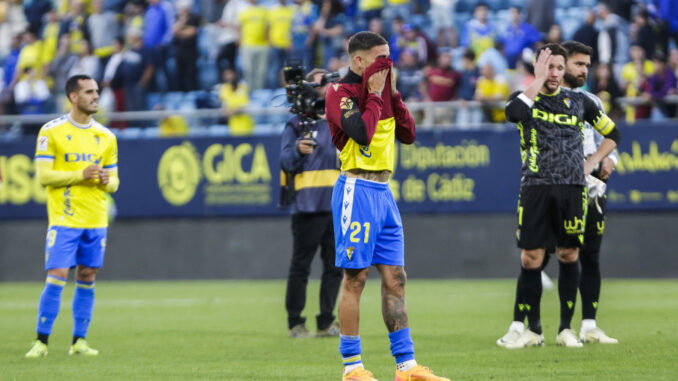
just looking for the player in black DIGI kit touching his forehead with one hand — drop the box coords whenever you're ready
[497,44,621,348]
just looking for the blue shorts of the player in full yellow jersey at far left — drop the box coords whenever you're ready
[45,226,108,270]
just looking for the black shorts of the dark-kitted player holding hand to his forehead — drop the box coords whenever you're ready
[516,185,587,250]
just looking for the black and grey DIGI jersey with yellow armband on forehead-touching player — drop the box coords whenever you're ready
[506,87,618,185]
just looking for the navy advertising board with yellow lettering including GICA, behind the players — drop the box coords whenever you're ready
[0,124,678,219]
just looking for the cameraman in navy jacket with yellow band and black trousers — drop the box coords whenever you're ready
[280,69,342,338]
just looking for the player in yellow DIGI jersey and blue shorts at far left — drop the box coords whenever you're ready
[26,75,120,358]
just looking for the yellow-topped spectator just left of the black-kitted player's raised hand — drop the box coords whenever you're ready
[474,64,509,123]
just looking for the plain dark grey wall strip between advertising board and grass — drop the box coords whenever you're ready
[0,212,678,281]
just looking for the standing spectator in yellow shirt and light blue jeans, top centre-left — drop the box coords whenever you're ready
[240,0,269,91]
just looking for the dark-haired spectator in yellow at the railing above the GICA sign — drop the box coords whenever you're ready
[219,68,254,136]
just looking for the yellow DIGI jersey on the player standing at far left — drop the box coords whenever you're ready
[35,115,118,229]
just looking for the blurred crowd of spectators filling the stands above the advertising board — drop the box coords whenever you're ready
[0,0,678,133]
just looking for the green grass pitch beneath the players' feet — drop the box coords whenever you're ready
[0,274,678,381]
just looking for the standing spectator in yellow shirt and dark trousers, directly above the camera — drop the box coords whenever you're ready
[267,0,294,88]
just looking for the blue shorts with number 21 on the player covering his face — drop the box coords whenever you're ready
[332,175,405,269]
